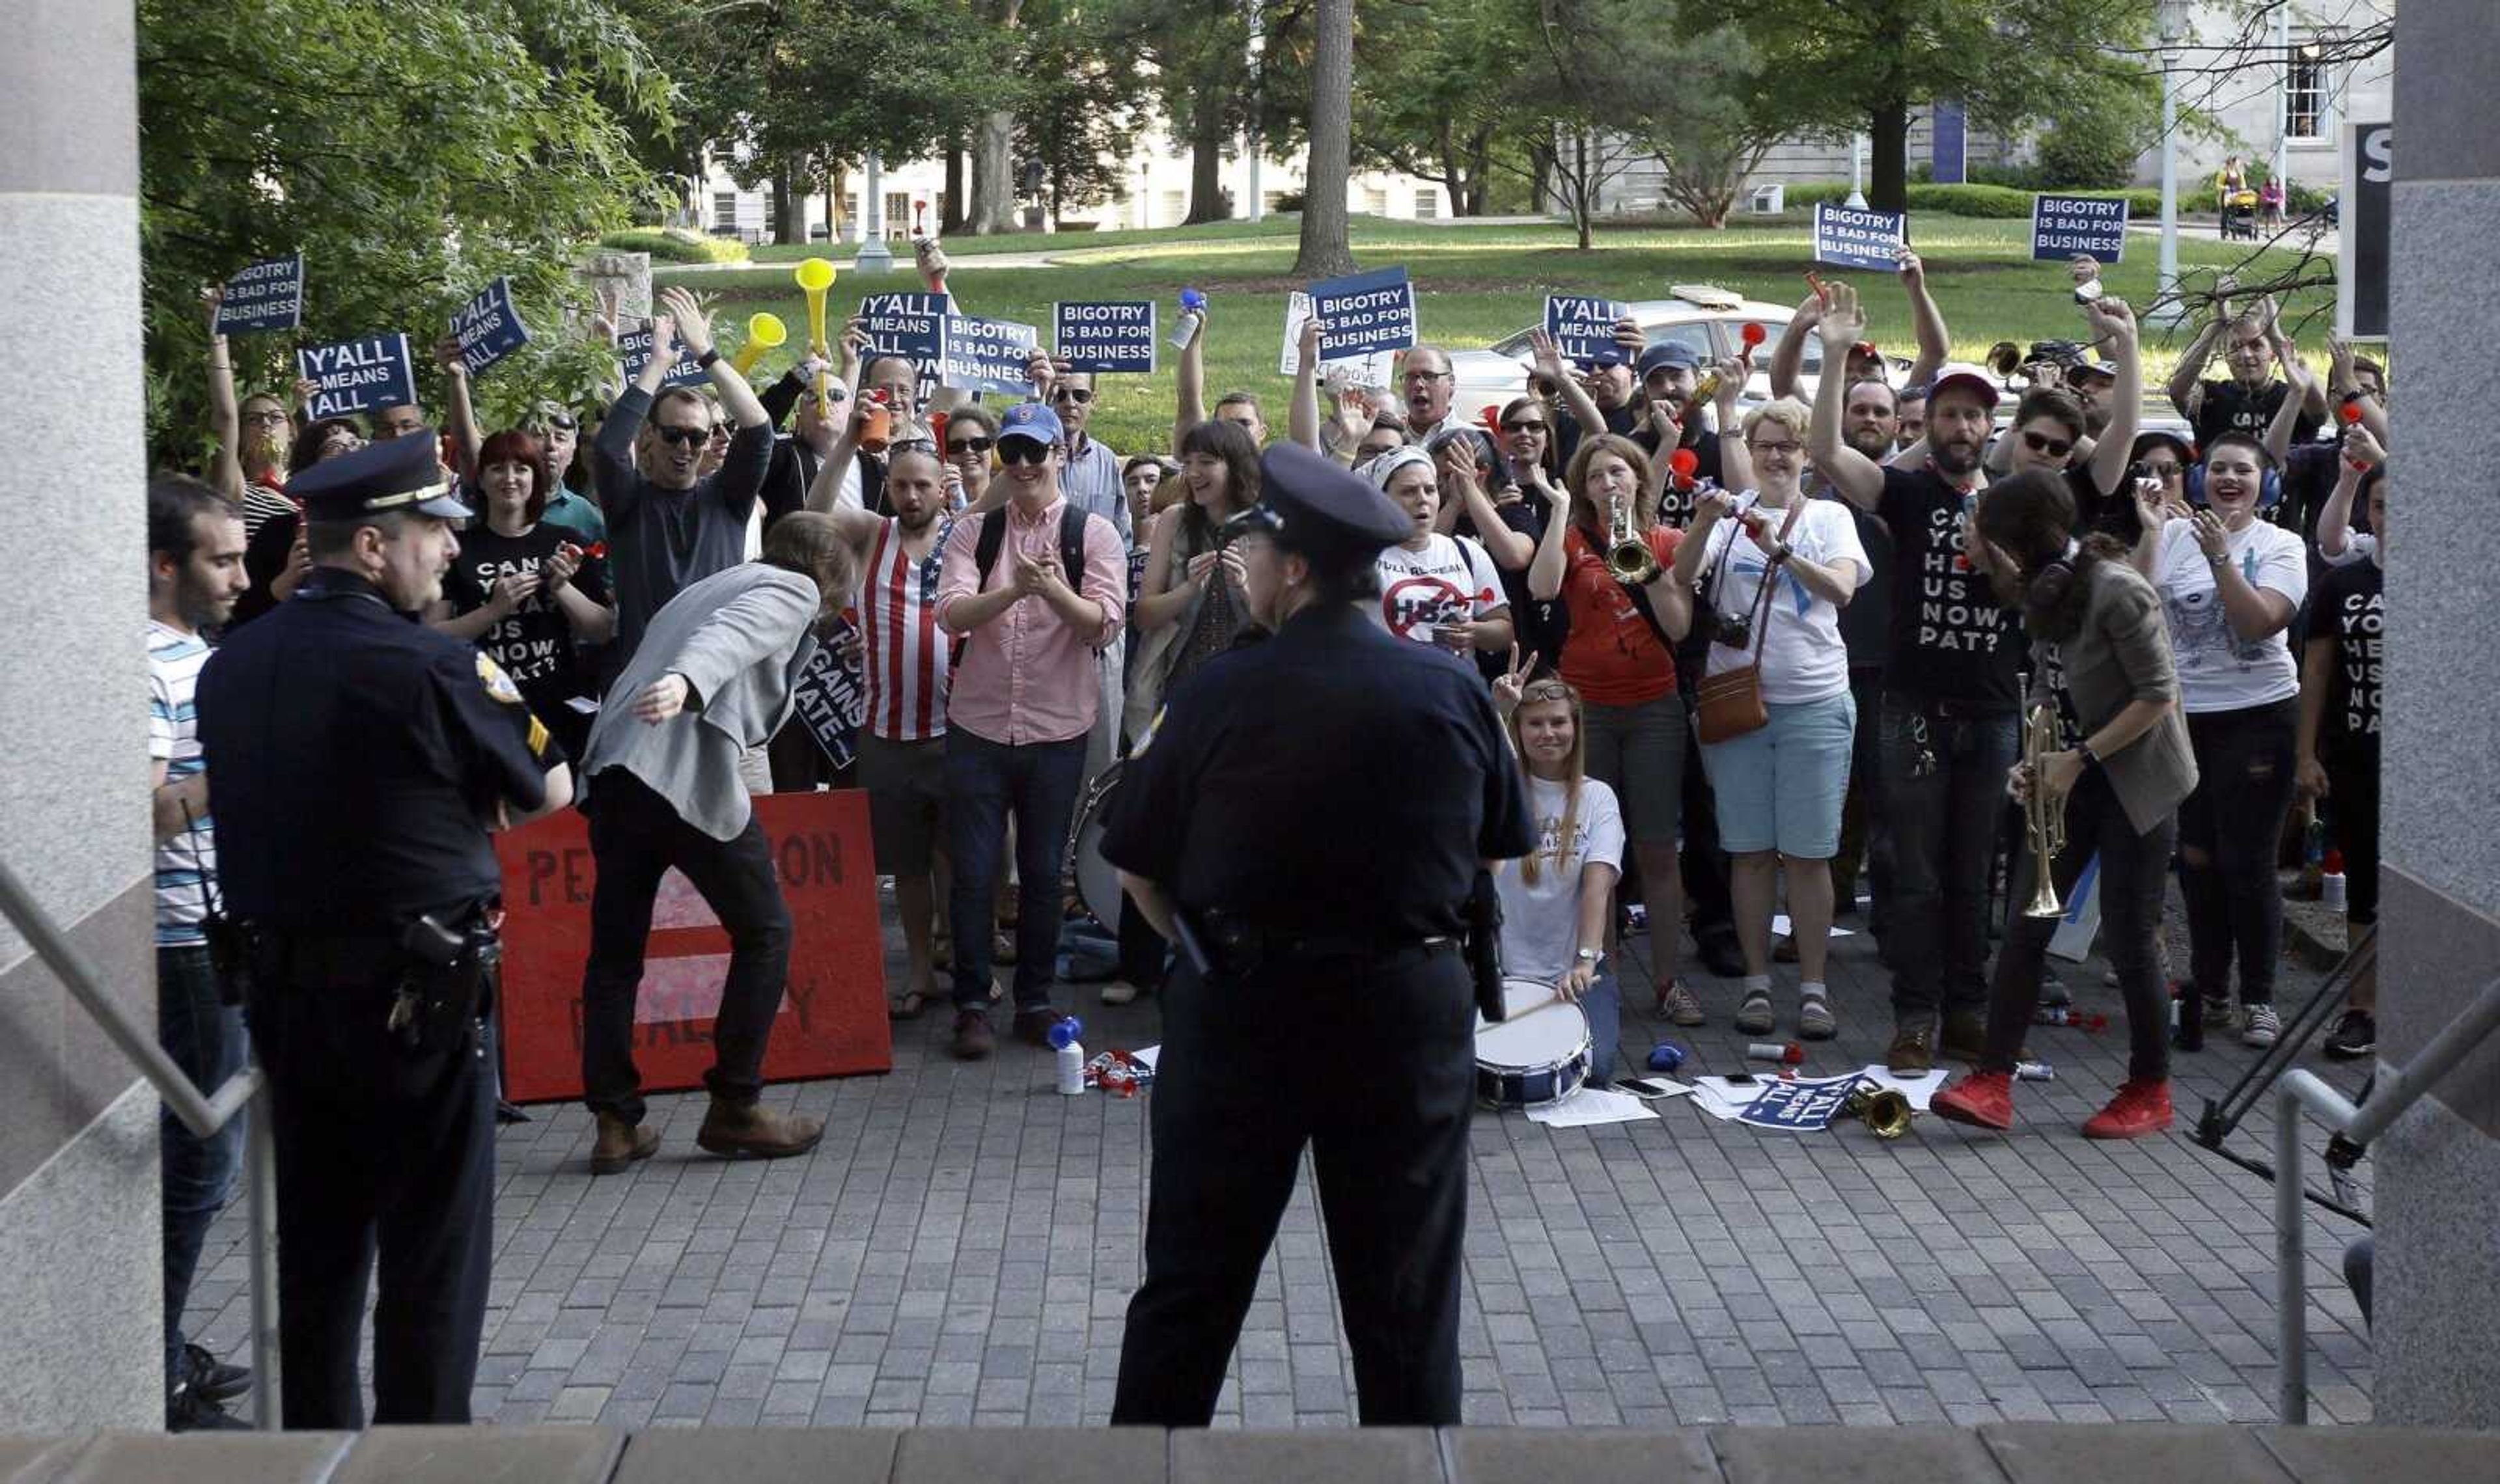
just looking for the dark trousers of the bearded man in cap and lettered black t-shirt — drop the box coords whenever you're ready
[1875,692,2020,1017]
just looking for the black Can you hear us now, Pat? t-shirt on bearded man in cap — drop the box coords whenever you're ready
[1875,465,2025,712]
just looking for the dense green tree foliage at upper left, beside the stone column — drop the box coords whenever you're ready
[137,0,670,465]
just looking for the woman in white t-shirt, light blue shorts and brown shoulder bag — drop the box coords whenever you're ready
[1675,397,1875,1039]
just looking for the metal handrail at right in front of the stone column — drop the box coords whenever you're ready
[2275,980,2500,1424]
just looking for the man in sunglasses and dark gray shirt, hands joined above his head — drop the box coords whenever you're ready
[590,287,773,665]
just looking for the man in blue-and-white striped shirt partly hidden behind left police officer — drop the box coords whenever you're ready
[148,474,250,1431]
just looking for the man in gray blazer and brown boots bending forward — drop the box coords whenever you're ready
[583,512,855,1174]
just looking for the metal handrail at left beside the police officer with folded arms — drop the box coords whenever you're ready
[0,862,277,1431]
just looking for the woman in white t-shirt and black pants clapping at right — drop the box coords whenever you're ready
[2135,432,2310,1047]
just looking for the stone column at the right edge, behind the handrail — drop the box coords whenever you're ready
[2372,0,2500,1427]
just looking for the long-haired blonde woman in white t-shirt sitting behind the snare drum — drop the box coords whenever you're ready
[1492,665,1622,1087]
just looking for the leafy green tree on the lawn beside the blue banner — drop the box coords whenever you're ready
[1710,0,2155,210]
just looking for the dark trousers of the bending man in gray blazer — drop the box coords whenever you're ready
[583,767,790,1124]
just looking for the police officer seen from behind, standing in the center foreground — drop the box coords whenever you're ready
[1102,445,1533,1427]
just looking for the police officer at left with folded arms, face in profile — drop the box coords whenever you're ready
[197,437,572,1429]
